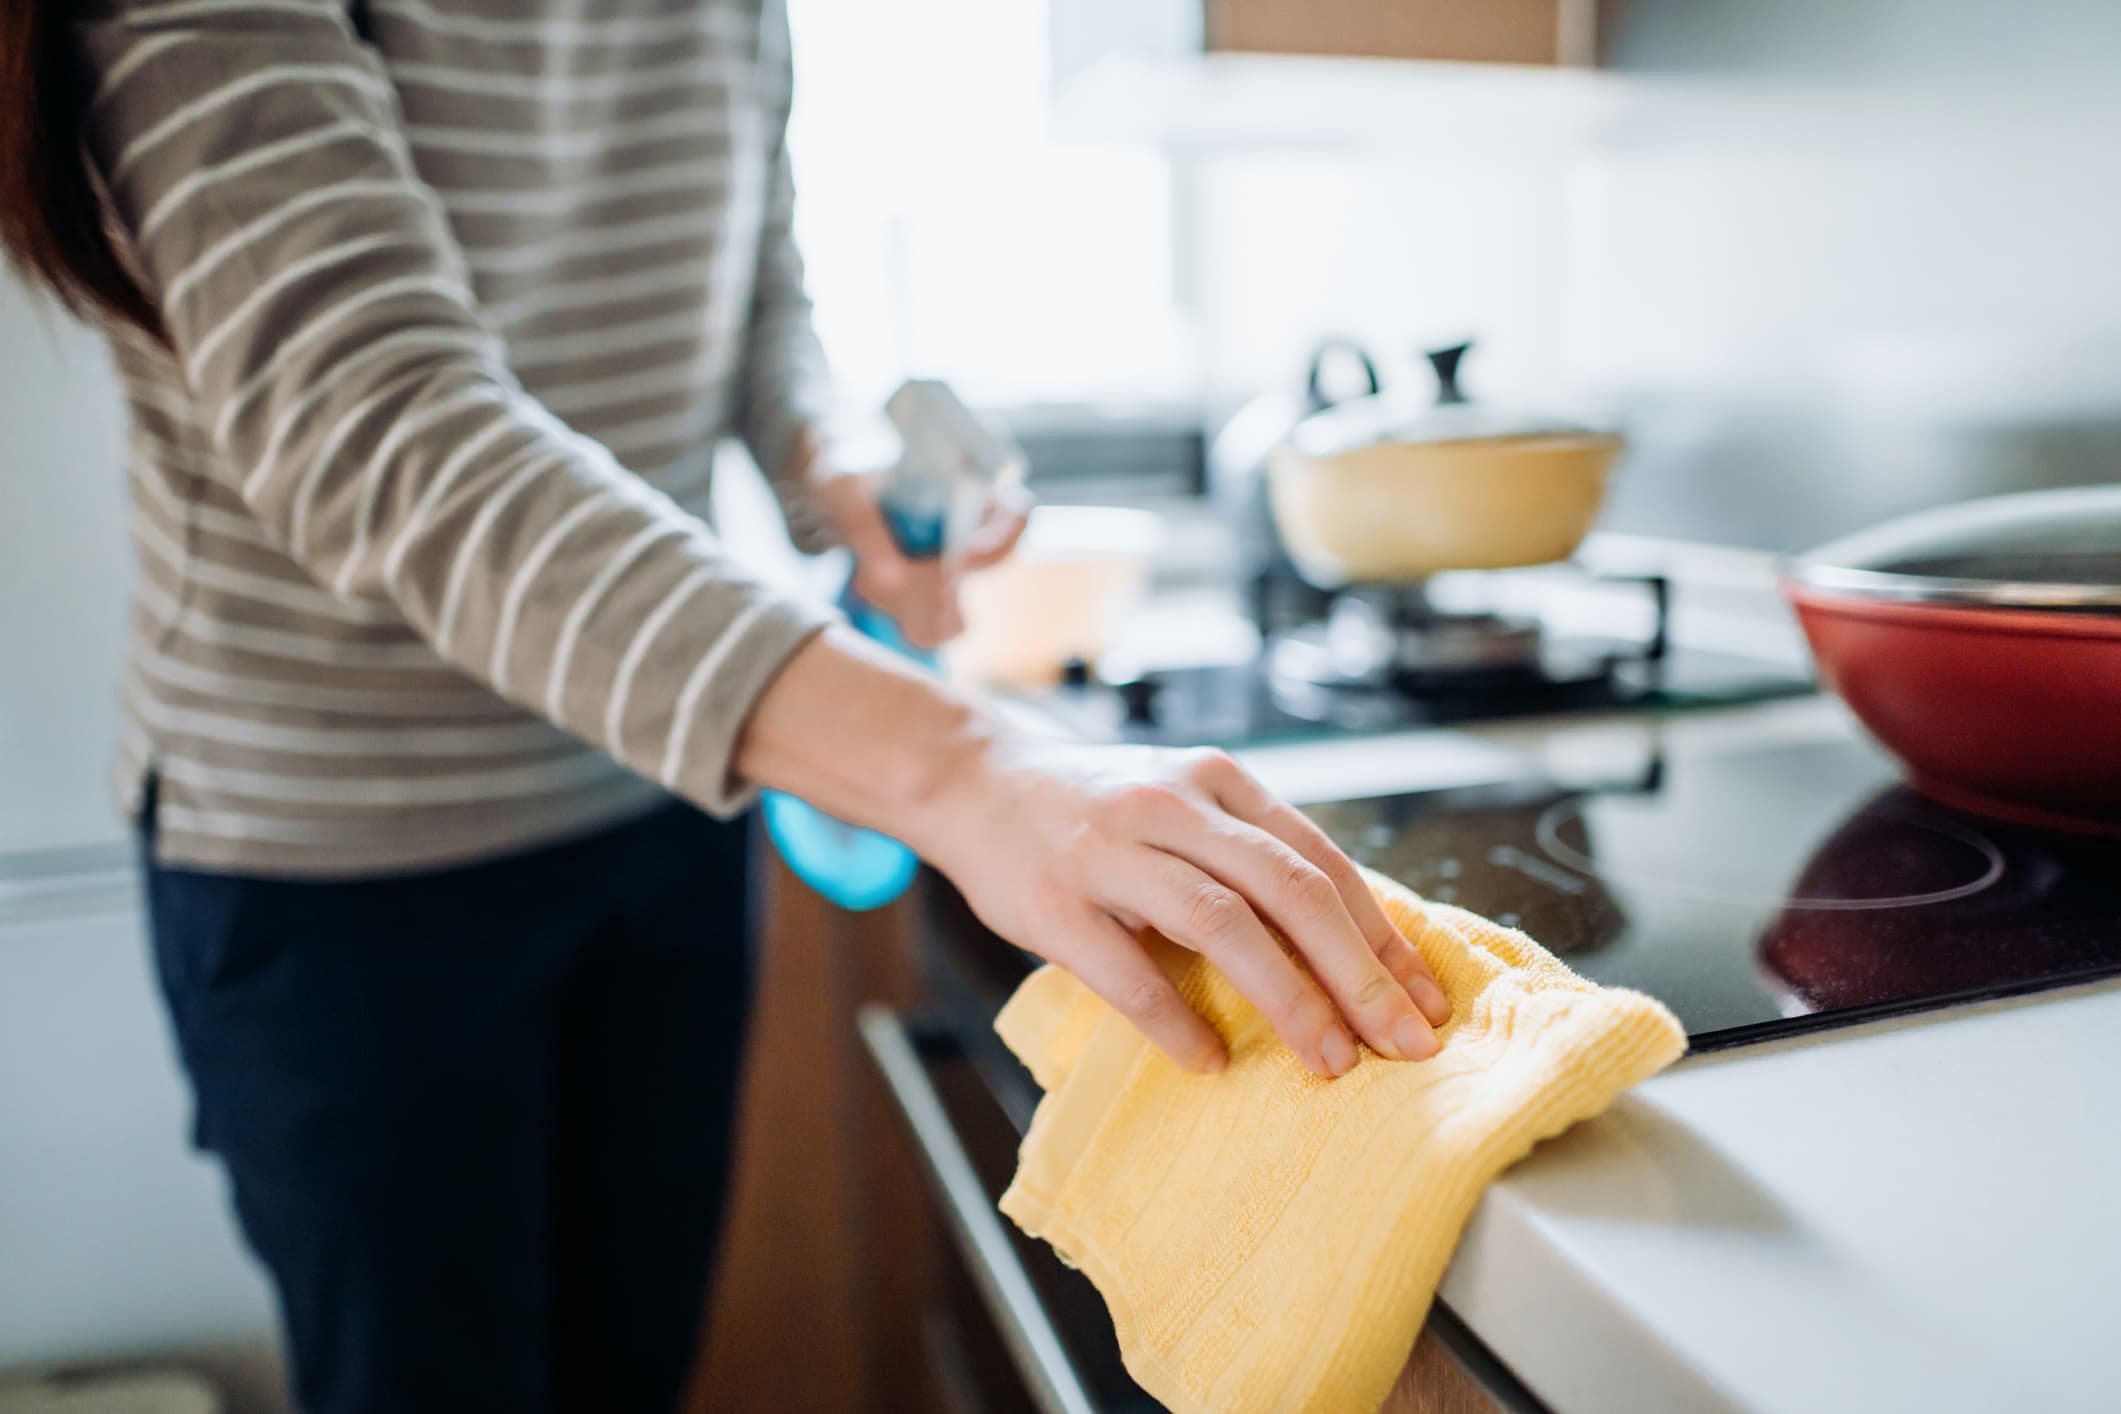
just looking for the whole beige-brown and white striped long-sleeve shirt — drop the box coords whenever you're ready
[81,0,844,876]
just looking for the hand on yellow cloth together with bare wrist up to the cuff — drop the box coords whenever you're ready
[736,628,1451,1075]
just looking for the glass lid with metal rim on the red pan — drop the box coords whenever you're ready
[1786,485,2121,613]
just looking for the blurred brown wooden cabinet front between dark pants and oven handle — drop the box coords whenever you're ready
[687,856,940,1414]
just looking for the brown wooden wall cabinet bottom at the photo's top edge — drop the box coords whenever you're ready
[1203,0,1610,66]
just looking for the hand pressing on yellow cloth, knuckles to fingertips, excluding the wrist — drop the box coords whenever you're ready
[918,733,1451,1075]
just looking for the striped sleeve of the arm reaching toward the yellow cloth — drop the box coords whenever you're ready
[81,0,829,810]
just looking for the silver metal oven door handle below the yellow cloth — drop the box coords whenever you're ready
[857,1003,1094,1414]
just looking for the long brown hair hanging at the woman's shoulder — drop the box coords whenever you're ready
[0,0,161,335]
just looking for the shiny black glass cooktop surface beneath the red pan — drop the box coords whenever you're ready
[1307,740,2121,1049]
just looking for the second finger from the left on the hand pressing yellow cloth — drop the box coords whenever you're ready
[1103,846,1360,1077]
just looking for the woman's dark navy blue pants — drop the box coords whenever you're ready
[148,806,755,1414]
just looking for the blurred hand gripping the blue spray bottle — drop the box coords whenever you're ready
[817,475,1031,649]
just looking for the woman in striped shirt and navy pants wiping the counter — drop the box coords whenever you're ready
[0,0,1444,1414]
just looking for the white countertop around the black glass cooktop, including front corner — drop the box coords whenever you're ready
[1243,700,2121,1414]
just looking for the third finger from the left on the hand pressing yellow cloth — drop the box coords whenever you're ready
[1145,803,1438,1060]
